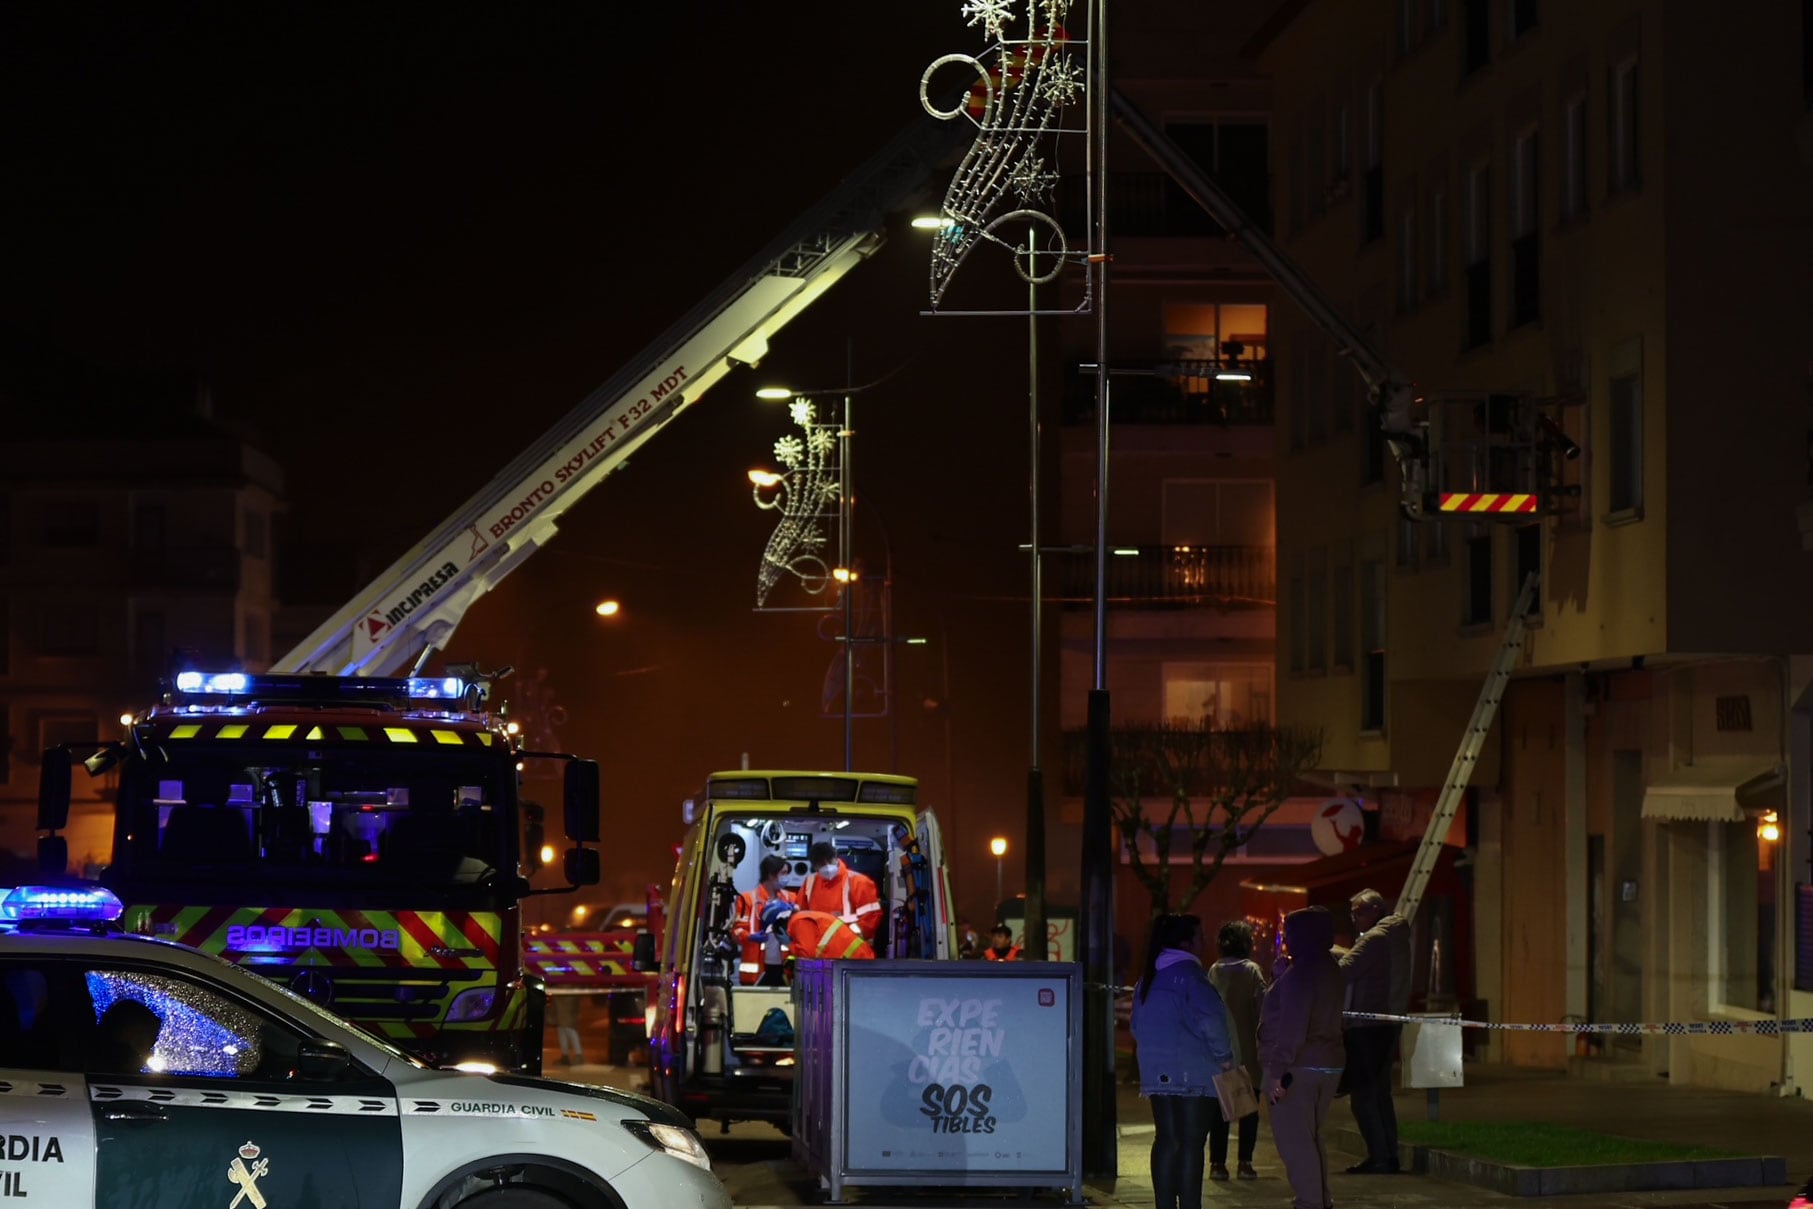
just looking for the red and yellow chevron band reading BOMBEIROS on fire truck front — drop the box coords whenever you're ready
[125,904,504,970]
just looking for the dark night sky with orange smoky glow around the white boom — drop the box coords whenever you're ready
[0,0,1075,917]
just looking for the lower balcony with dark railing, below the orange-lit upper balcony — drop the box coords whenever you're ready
[1048,546,1278,607]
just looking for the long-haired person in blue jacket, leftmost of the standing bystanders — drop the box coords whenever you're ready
[1133,915,1235,1209]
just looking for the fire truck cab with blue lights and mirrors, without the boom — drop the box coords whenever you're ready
[40,671,598,1073]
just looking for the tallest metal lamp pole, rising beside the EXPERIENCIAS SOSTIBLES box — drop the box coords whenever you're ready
[1081,0,1120,1178]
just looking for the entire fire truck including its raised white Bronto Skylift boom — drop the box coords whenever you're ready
[38,94,968,1071]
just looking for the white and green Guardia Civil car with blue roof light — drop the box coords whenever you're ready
[0,888,731,1209]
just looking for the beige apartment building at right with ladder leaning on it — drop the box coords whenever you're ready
[1253,0,1813,1091]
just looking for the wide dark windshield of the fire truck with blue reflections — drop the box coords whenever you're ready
[112,745,515,888]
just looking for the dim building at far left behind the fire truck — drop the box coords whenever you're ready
[0,416,283,868]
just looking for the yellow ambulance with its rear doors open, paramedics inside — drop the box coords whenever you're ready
[642,770,955,1129]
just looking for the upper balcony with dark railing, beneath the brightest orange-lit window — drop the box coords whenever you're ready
[1064,361,1273,428]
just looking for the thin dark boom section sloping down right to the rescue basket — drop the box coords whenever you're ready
[1110,91,1429,518]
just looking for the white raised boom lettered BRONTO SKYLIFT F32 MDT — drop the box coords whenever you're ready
[272,100,974,676]
